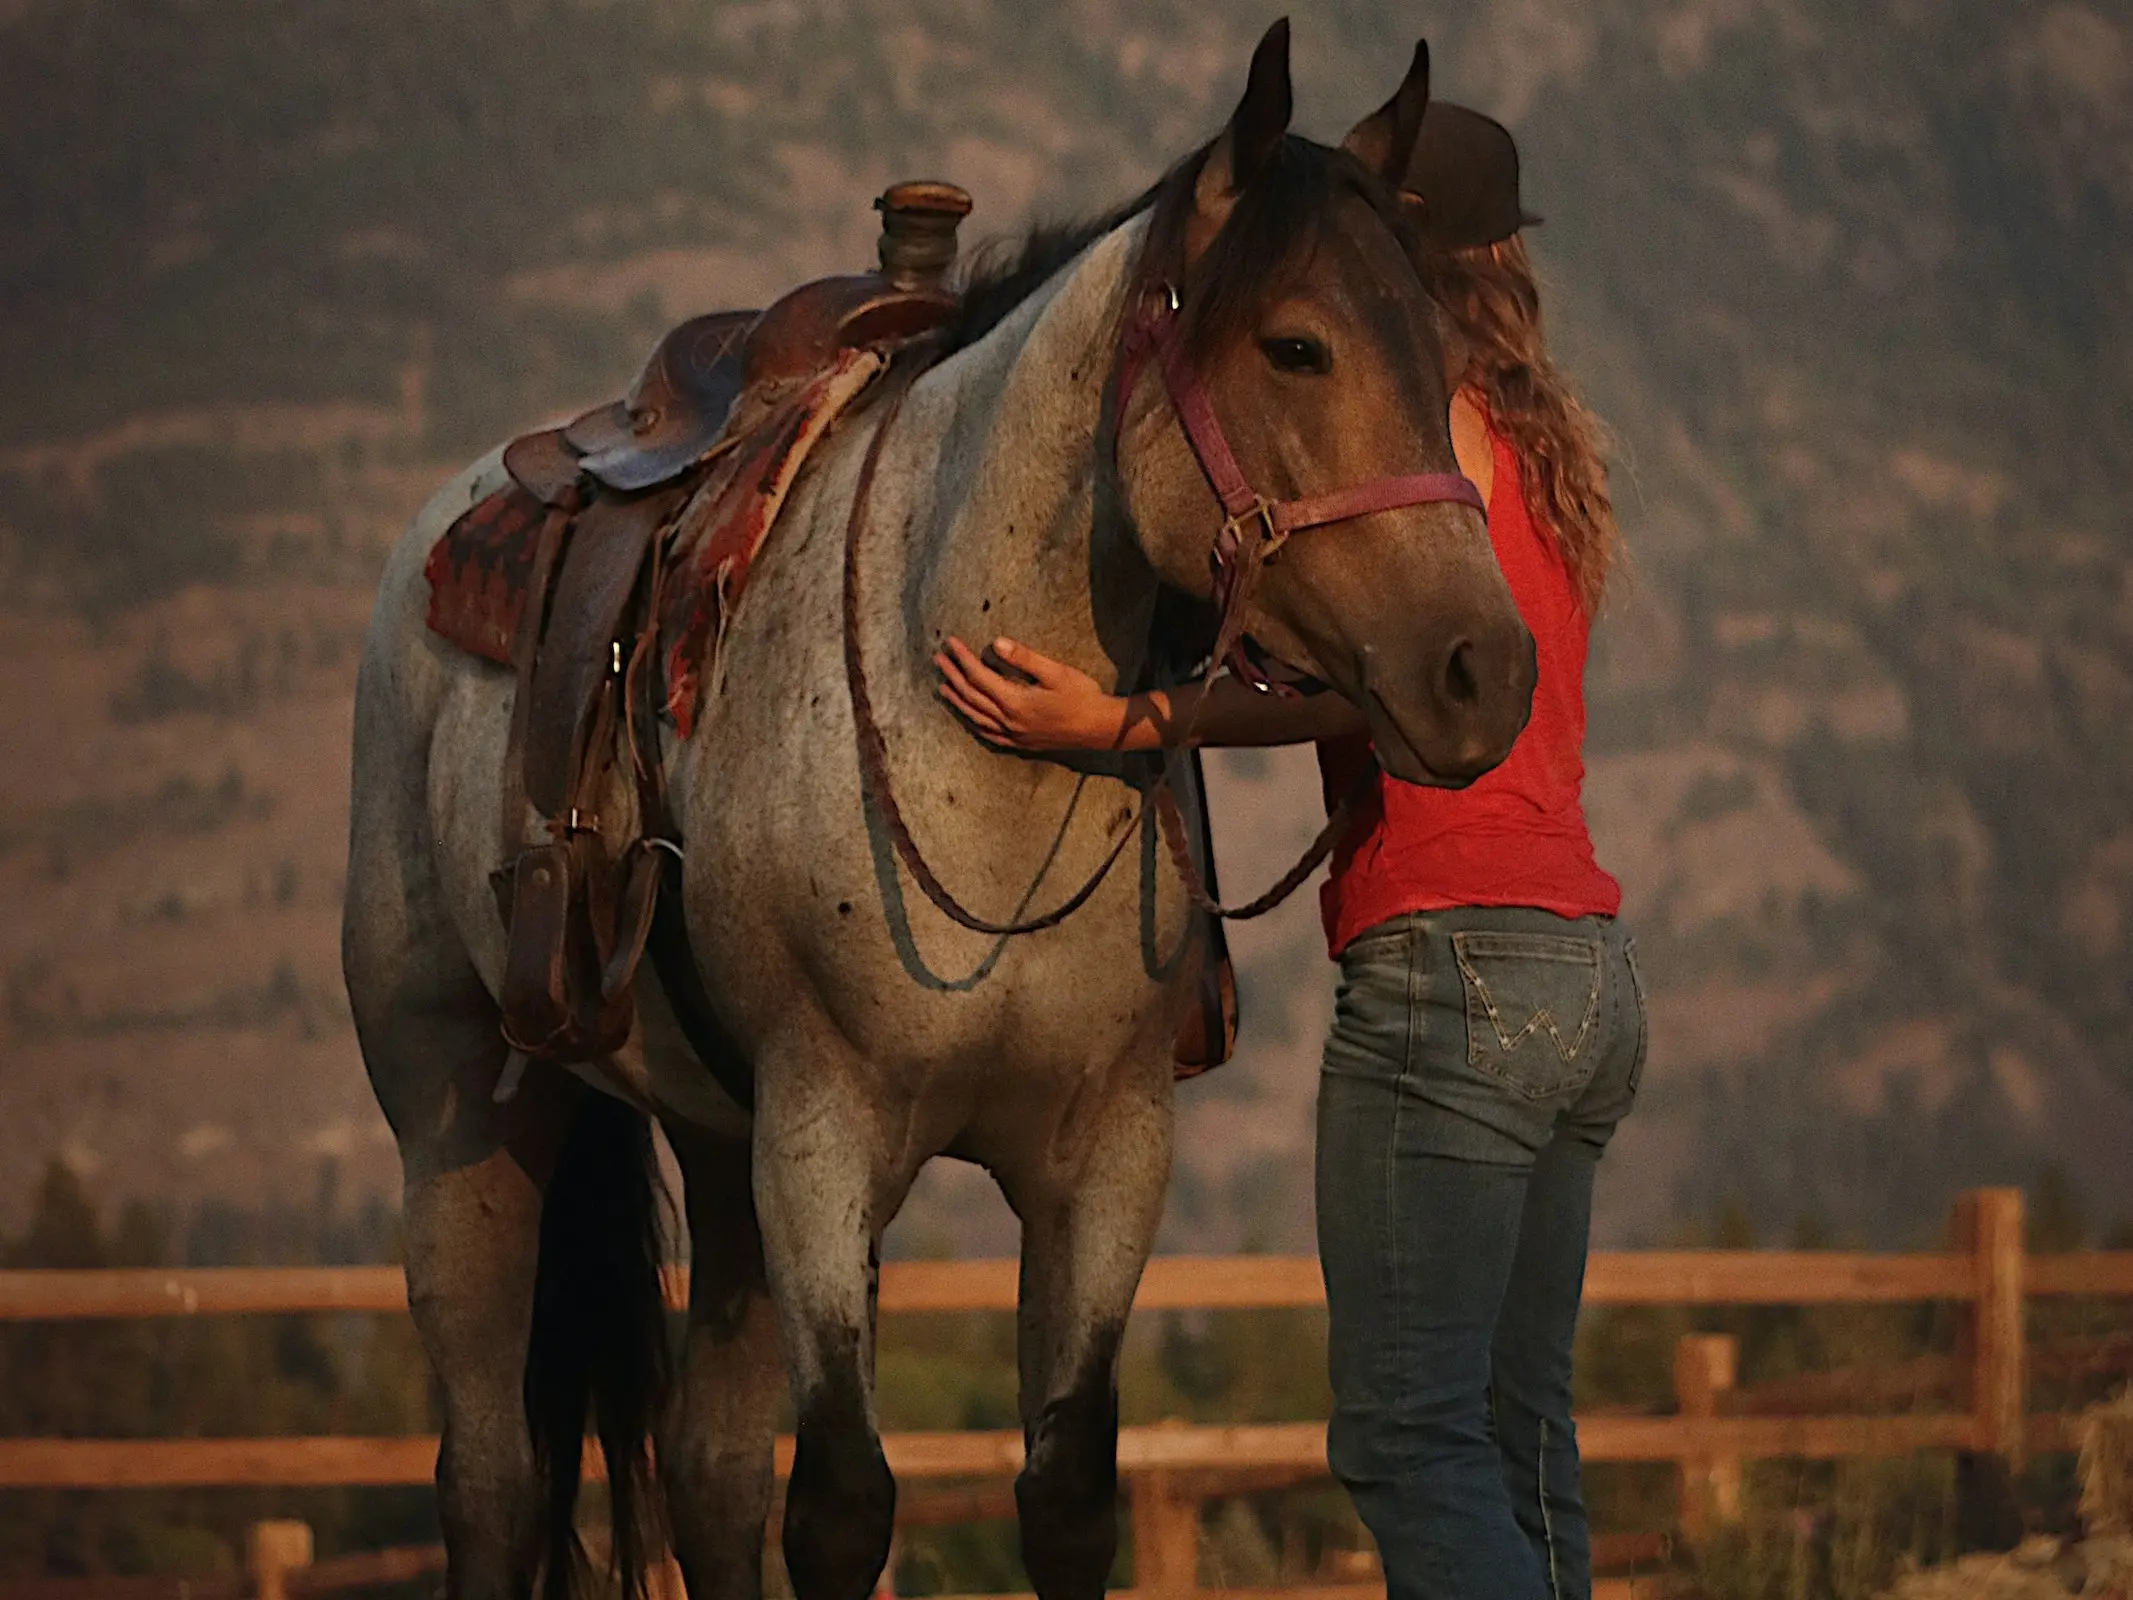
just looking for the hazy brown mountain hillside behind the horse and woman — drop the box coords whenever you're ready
[0,0,2133,1244]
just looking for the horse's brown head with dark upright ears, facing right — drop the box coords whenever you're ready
[1120,23,1534,785]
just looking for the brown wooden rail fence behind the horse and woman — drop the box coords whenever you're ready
[0,1188,2133,1594]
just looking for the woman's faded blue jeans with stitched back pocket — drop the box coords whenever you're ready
[1318,907,1645,1600]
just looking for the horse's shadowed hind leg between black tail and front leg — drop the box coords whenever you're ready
[659,1124,785,1600]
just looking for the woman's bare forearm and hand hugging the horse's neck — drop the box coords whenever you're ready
[934,638,1367,751]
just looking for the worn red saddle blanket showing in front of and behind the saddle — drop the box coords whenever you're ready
[424,350,885,738]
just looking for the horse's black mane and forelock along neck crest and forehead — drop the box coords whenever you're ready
[943,134,1423,354]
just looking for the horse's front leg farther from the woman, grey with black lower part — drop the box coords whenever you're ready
[755,1039,896,1600]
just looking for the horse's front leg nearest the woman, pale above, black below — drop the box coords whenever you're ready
[1003,1066,1171,1600]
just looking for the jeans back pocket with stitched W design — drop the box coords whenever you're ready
[1453,930,1604,1101]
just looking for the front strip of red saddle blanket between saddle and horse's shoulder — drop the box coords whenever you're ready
[659,350,887,738]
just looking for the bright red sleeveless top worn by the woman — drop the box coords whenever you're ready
[1318,433,1621,956]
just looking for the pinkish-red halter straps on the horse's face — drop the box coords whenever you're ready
[1116,286,1489,689]
